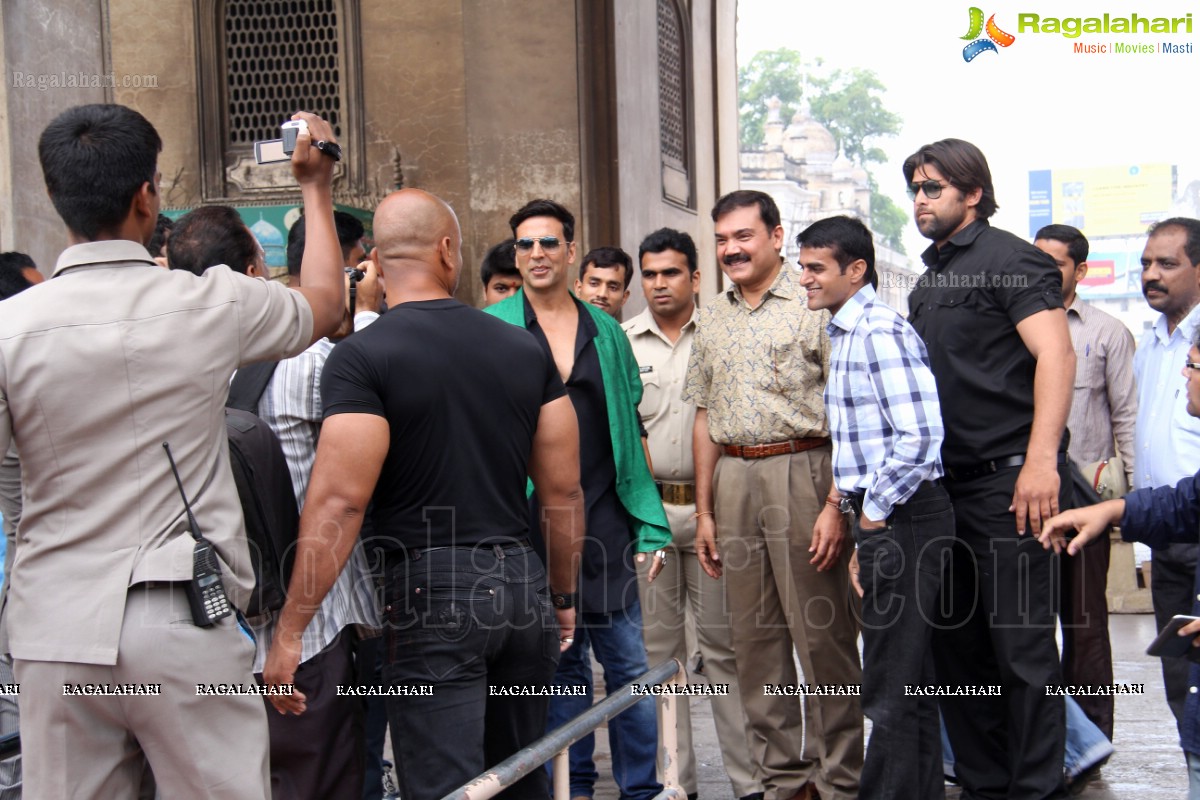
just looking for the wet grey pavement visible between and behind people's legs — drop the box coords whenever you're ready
[585,614,1187,800]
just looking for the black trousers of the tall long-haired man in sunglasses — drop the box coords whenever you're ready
[934,465,1070,800]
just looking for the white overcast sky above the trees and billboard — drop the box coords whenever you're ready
[738,0,1200,255]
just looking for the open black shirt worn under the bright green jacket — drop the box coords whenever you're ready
[524,297,637,612]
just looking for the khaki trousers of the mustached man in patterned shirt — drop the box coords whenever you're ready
[714,447,863,800]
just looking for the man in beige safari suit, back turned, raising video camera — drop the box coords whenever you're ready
[0,104,344,800]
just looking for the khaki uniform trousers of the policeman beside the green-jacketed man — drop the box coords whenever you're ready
[637,504,762,798]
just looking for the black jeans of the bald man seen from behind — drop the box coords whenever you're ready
[383,546,558,800]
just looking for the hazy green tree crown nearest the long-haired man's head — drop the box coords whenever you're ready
[809,67,900,166]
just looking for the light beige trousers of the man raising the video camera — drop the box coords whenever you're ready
[14,584,270,800]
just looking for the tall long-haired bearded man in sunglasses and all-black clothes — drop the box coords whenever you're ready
[904,139,1075,799]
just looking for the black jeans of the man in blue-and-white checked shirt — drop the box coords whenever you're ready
[853,482,954,800]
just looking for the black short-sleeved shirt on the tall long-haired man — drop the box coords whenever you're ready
[908,219,1066,468]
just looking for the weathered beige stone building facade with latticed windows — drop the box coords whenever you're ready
[0,0,738,313]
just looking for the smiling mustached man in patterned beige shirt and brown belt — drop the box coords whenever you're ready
[683,191,863,800]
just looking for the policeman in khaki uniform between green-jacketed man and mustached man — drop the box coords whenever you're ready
[622,228,761,799]
